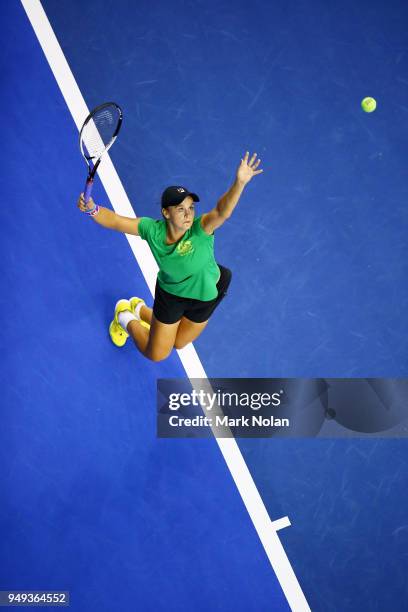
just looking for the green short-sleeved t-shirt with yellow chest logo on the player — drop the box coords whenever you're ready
[139,216,220,302]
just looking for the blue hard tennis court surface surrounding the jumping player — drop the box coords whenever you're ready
[0,0,408,612]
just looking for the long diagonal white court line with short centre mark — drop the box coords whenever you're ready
[21,0,310,612]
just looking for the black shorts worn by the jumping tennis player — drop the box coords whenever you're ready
[153,264,232,324]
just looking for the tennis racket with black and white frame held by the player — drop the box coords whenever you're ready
[79,102,123,203]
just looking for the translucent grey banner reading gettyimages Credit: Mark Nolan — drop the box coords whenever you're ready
[157,378,408,438]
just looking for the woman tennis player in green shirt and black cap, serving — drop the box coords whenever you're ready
[78,151,263,361]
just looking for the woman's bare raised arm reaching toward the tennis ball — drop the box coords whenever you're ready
[201,151,263,234]
